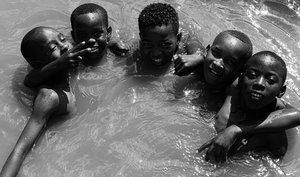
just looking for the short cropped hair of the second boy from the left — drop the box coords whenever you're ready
[71,3,108,28]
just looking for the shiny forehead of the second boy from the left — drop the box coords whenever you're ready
[74,12,105,28]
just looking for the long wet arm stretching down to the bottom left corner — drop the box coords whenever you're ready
[0,89,59,177]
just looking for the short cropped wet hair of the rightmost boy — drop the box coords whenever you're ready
[244,51,287,85]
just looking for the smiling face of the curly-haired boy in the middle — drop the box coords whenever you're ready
[140,24,180,66]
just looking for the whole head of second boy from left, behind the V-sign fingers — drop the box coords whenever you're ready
[71,3,111,60]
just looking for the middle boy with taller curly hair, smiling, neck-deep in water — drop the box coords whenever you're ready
[128,3,203,75]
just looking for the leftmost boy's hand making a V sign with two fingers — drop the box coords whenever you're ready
[58,41,93,68]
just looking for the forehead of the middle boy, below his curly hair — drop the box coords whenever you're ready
[140,24,176,40]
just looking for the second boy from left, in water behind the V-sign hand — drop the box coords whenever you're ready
[71,3,128,66]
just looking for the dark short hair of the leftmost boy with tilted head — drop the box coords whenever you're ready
[20,26,50,68]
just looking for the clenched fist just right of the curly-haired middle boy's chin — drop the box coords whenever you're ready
[174,54,204,76]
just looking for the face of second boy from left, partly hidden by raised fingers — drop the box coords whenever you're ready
[72,13,111,60]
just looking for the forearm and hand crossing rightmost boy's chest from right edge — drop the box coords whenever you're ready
[198,108,300,162]
